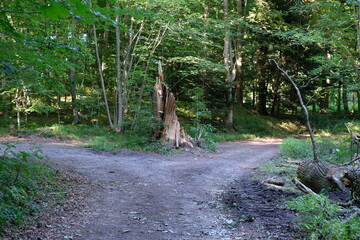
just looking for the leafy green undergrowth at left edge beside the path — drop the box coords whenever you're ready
[0,143,58,234]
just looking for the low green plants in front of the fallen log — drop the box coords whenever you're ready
[288,194,360,240]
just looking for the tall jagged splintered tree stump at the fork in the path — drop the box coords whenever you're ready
[153,62,193,148]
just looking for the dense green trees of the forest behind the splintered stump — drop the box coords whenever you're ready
[0,0,360,134]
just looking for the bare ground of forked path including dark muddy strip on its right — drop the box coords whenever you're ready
[0,139,302,240]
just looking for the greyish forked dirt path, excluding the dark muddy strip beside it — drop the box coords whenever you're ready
[7,139,281,240]
